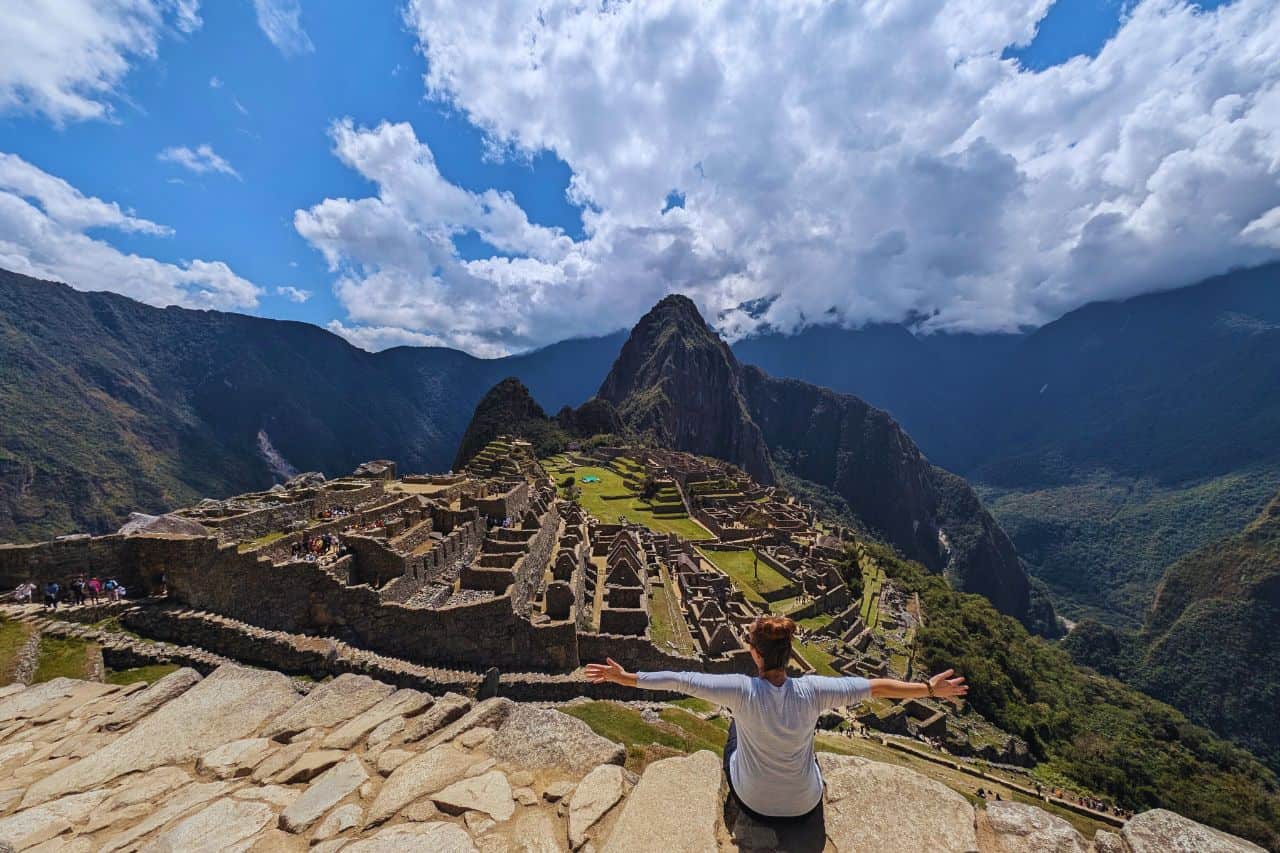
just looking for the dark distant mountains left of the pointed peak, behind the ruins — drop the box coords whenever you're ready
[0,270,623,542]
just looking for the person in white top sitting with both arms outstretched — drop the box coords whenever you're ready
[586,616,969,822]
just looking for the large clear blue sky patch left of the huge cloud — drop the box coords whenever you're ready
[0,0,582,325]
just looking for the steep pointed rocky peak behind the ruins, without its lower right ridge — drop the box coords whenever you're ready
[596,296,773,484]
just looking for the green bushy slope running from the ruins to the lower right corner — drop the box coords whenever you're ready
[865,544,1280,848]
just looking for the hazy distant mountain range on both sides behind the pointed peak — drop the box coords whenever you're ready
[0,264,1280,626]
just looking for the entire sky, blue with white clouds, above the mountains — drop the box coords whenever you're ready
[0,0,1280,355]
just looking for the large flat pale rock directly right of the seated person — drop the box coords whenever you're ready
[824,753,978,853]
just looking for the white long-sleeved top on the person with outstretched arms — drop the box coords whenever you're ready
[636,672,872,817]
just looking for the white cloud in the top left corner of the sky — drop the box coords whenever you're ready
[0,0,201,124]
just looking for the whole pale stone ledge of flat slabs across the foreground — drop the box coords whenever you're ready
[0,665,1262,853]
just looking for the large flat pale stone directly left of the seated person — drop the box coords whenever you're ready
[604,751,721,853]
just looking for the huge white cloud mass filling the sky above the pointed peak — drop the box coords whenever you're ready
[296,0,1280,351]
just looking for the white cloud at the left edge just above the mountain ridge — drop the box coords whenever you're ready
[0,152,261,309]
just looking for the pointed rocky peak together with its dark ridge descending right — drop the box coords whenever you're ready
[599,296,1056,633]
